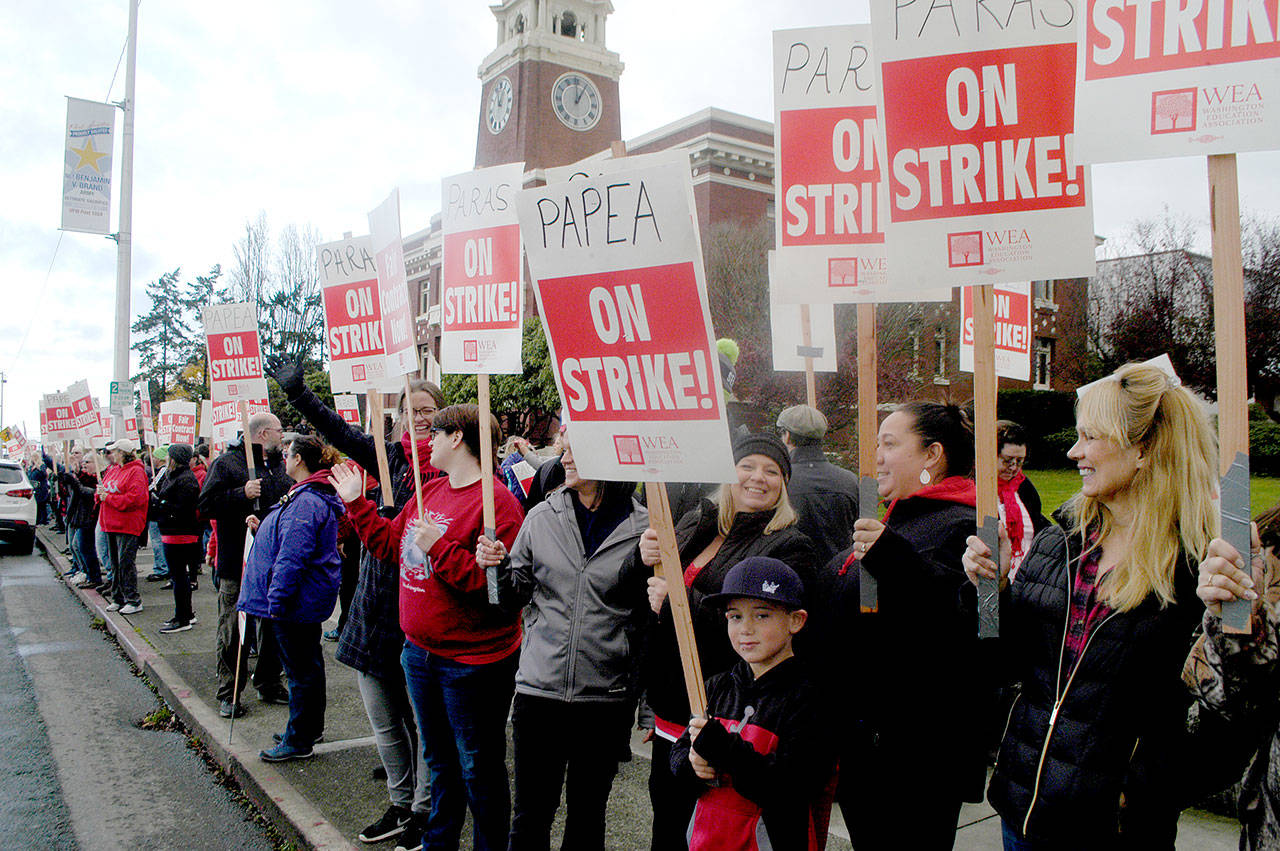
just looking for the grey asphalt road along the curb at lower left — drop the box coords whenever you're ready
[0,550,274,851]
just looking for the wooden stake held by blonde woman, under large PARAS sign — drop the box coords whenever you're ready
[973,284,1000,639]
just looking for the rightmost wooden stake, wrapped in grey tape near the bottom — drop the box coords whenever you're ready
[1208,154,1253,633]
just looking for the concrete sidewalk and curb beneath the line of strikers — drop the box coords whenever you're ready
[36,527,1239,851]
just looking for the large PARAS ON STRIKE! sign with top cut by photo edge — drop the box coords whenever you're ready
[870,0,1094,288]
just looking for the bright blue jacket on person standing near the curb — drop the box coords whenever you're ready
[237,471,346,623]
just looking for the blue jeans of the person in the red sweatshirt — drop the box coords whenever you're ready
[401,641,520,851]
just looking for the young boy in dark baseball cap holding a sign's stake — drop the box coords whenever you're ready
[671,555,833,851]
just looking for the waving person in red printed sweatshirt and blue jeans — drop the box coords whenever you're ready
[333,404,524,851]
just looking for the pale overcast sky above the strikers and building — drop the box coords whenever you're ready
[0,0,1280,431]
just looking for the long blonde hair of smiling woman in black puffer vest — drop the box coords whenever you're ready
[1066,363,1219,612]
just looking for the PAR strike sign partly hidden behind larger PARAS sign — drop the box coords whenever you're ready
[771,24,896,305]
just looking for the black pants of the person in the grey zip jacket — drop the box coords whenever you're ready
[508,694,635,851]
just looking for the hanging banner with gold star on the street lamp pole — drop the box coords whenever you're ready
[61,97,115,234]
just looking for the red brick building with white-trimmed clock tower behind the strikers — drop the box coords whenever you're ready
[404,0,1087,401]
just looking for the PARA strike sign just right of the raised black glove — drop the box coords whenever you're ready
[316,237,386,393]
